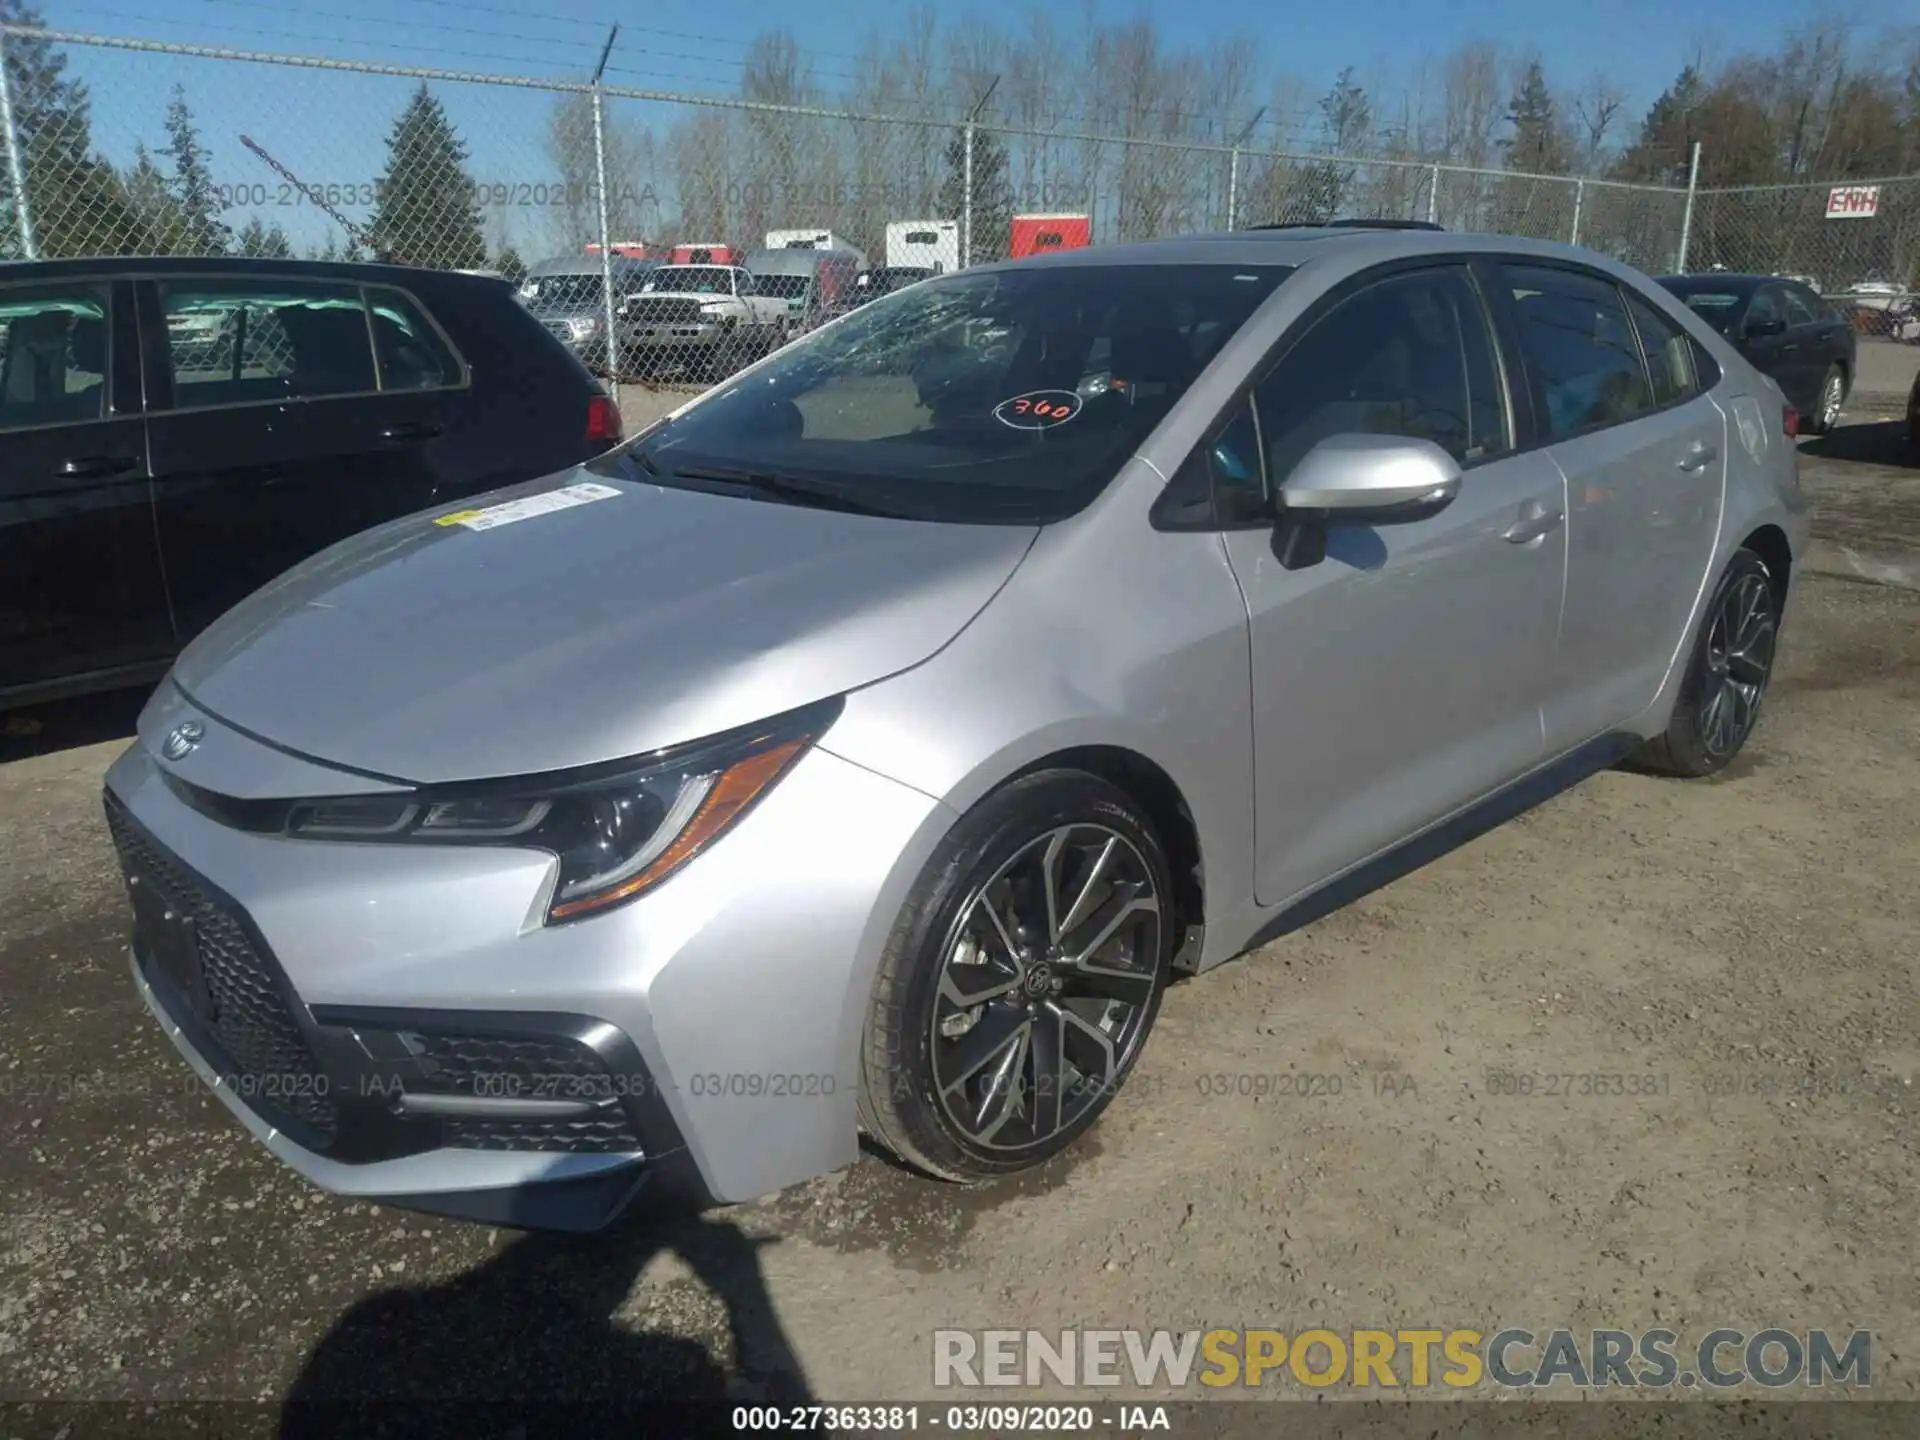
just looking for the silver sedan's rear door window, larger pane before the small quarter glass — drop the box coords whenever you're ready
[1501,265,1653,440]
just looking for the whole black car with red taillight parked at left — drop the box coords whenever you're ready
[0,259,620,708]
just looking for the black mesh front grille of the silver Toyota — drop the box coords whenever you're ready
[106,793,338,1140]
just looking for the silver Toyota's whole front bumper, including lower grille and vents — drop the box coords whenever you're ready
[106,710,945,1229]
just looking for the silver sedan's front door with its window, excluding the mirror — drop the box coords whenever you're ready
[1225,265,1565,904]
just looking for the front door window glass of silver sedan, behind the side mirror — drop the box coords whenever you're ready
[1254,265,1511,488]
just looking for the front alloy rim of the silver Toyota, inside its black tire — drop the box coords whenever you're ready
[931,824,1164,1152]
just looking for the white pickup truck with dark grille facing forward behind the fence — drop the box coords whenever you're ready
[618,265,787,380]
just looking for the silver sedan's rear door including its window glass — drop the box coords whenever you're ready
[1500,263,1726,753]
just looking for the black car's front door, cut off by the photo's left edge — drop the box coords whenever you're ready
[0,278,173,695]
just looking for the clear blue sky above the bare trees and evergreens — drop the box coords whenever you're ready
[15,0,1889,252]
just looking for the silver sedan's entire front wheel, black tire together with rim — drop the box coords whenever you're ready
[860,770,1175,1183]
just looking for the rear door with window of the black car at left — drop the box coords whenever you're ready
[142,276,445,641]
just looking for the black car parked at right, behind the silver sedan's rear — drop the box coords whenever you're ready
[1661,271,1859,436]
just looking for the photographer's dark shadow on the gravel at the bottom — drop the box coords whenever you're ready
[280,1217,812,1440]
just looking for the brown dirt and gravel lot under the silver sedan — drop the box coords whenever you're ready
[0,424,1920,1432]
